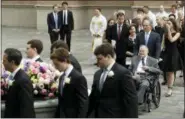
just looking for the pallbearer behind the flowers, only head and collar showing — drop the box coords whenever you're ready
[26,39,43,62]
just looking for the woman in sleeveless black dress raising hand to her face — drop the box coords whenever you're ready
[164,19,182,97]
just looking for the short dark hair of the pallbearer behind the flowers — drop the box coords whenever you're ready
[27,39,43,54]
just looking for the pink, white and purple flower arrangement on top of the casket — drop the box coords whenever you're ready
[1,60,60,100]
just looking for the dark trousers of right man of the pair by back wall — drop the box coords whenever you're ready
[60,25,71,51]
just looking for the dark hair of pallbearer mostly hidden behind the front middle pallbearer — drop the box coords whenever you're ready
[50,40,69,53]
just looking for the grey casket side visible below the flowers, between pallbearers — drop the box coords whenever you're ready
[1,98,58,118]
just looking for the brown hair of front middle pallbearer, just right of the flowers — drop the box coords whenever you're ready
[50,48,70,63]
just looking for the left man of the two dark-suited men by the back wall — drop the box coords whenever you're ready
[47,5,61,44]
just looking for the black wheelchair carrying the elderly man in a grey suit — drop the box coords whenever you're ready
[138,71,161,112]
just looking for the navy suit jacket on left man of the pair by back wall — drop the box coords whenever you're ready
[47,12,62,33]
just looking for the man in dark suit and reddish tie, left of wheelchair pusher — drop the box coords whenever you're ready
[109,12,129,66]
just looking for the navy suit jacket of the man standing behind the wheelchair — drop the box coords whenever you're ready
[135,31,161,59]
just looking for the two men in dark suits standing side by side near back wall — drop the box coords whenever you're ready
[47,2,74,51]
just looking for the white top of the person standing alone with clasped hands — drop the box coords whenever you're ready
[90,15,107,37]
